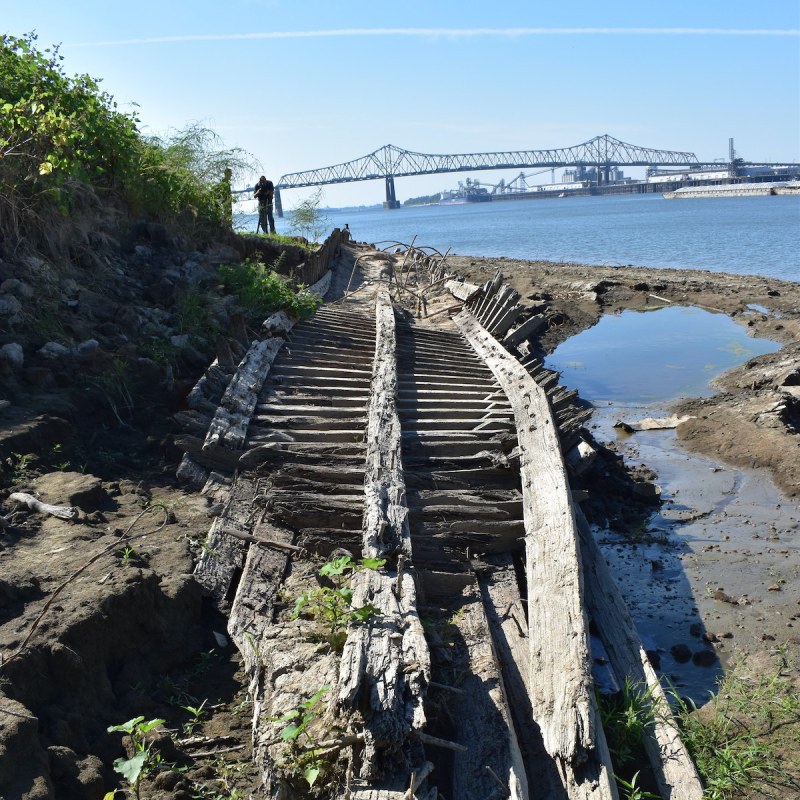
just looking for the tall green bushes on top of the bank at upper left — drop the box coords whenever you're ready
[0,34,255,252]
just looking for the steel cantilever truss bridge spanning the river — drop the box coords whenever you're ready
[275,134,704,216]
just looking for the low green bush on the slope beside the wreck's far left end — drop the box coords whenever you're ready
[219,254,322,319]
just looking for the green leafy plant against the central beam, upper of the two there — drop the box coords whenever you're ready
[292,556,386,652]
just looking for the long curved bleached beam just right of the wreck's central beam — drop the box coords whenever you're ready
[455,312,616,798]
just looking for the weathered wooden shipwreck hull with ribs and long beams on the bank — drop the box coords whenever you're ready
[181,234,702,800]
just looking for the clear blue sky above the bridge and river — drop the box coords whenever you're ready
[0,0,800,207]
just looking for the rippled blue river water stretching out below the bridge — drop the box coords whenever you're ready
[246,192,800,281]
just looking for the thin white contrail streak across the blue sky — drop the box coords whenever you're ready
[65,28,800,47]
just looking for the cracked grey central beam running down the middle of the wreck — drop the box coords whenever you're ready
[338,289,430,780]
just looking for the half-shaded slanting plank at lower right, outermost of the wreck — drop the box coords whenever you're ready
[576,512,703,800]
